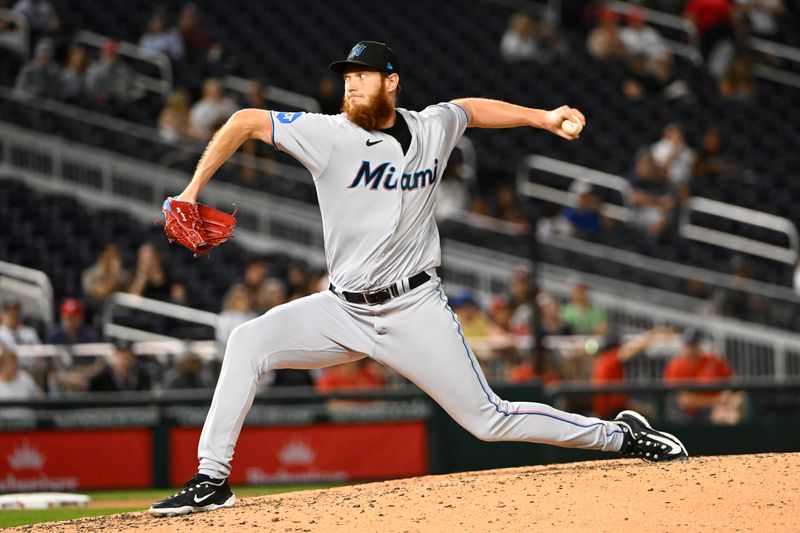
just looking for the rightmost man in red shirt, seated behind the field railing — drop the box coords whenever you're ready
[664,329,732,419]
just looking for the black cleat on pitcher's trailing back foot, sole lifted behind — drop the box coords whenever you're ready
[614,411,689,463]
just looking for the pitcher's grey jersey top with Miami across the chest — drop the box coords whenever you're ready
[270,103,468,291]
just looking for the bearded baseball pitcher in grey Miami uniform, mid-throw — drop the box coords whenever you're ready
[150,41,688,516]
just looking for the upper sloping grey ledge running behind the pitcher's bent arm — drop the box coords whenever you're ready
[0,85,308,186]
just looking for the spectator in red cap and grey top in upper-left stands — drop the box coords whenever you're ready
[86,39,134,106]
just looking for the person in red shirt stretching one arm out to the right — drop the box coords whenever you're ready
[592,327,675,419]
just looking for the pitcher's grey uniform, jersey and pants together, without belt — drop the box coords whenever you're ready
[191,104,623,478]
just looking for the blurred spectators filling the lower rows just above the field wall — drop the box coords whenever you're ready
[0,243,743,423]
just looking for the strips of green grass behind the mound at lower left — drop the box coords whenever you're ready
[0,484,339,528]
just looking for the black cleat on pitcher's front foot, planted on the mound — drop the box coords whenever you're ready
[148,474,236,516]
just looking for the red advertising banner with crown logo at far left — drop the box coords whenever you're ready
[0,428,153,492]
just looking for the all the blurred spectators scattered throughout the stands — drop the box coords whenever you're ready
[0,0,800,423]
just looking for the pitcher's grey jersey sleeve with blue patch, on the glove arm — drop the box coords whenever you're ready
[269,111,337,179]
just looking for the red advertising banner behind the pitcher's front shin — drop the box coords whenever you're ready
[170,421,428,485]
